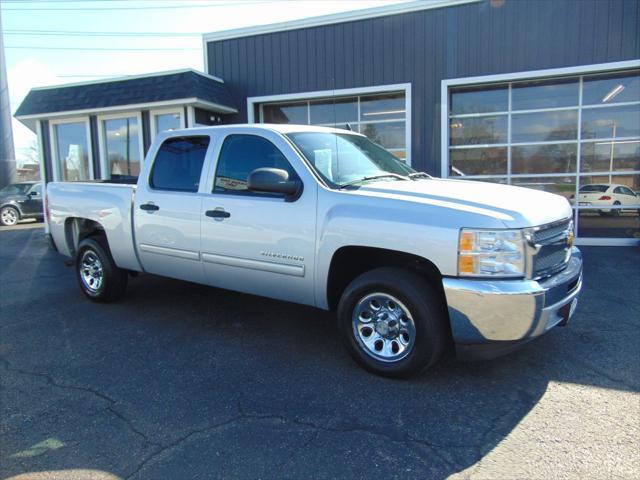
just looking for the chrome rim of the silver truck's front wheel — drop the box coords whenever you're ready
[351,293,416,362]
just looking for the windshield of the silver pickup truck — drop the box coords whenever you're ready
[287,132,415,187]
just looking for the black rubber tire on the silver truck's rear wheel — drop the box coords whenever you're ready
[75,236,128,303]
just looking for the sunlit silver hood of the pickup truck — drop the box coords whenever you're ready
[358,178,572,228]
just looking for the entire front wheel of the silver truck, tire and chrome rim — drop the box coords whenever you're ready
[338,267,448,377]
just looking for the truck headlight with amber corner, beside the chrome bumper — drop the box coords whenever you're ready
[458,228,525,277]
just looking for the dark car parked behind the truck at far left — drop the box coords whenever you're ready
[0,182,44,226]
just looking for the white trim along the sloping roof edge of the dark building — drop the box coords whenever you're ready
[202,0,483,44]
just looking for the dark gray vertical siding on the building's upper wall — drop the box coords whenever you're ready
[207,0,640,174]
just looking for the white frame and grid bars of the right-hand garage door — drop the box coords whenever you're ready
[440,60,640,245]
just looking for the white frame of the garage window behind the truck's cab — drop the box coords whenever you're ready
[247,83,411,165]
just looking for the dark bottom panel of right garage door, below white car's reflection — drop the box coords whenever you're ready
[578,209,640,239]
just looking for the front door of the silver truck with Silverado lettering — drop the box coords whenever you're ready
[201,130,317,304]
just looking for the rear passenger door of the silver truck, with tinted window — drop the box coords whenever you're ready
[134,135,211,283]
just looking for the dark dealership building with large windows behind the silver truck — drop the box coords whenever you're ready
[15,0,640,245]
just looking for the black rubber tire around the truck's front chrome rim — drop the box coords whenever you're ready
[338,267,450,377]
